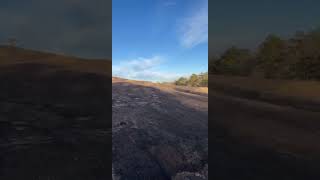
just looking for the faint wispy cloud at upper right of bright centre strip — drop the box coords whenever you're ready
[179,1,208,48]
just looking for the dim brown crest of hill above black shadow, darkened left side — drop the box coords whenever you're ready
[0,46,112,76]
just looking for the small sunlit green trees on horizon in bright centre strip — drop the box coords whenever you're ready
[174,72,208,87]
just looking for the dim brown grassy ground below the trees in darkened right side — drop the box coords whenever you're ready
[209,75,320,158]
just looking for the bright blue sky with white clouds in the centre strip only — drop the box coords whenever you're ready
[112,0,208,81]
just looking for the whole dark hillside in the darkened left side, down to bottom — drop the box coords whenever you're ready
[0,47,112,180]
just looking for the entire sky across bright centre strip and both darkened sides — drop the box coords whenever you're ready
[0,0,320,81]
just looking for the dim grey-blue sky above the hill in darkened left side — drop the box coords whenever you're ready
[0,0,112,59]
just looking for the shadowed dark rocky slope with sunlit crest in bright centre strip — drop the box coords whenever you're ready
[112,78,208,180]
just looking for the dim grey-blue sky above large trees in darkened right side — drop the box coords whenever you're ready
[209,0,320,56]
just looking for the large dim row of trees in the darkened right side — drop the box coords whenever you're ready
[209,29,320,80]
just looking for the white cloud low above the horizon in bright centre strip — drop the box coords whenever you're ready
[112,56,182,82]
